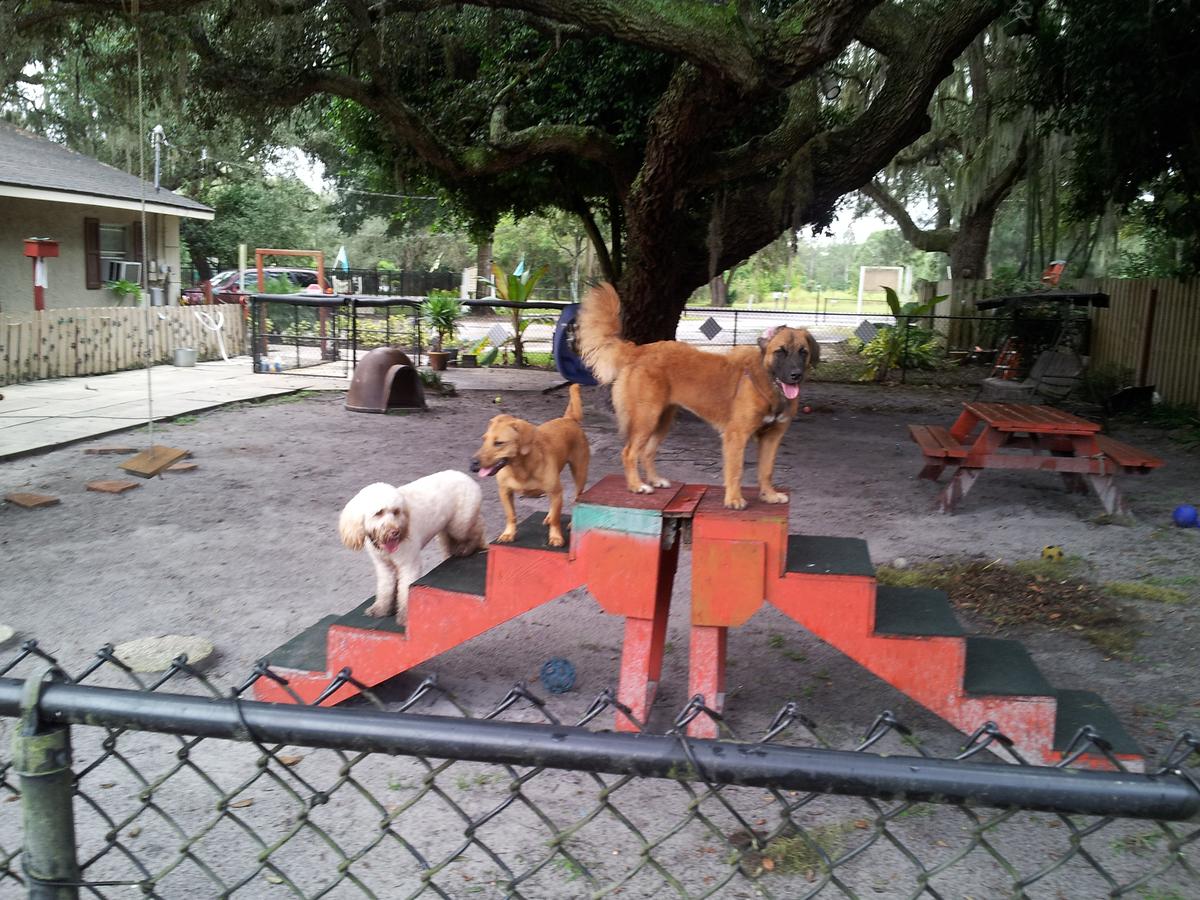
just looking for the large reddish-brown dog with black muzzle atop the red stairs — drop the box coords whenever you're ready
[578,284,820,509]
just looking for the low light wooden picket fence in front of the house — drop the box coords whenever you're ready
[0,305,246,384]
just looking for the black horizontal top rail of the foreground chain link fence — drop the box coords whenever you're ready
[0,678,1200,821]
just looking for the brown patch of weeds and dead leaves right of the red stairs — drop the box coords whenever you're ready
[876,557,1132,658]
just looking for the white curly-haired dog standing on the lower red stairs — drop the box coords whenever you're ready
[337,470,485,625]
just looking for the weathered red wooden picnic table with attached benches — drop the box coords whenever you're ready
[908,402,1163,514]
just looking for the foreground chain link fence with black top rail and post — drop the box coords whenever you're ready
[0,641,1200,900]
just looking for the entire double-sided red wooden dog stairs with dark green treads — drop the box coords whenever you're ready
[256,476,1141,768]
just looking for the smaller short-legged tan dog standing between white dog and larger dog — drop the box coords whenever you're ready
[470,384,592,547]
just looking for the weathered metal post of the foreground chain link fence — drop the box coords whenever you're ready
[12,665,79,900]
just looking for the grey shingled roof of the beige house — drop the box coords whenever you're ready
[0,121,212,212]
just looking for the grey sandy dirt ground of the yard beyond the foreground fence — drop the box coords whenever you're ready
[0,383,1200,896]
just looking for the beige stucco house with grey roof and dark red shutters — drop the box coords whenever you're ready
[0,121,212,314]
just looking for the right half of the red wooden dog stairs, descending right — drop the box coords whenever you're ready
[690,488,1142,768]
